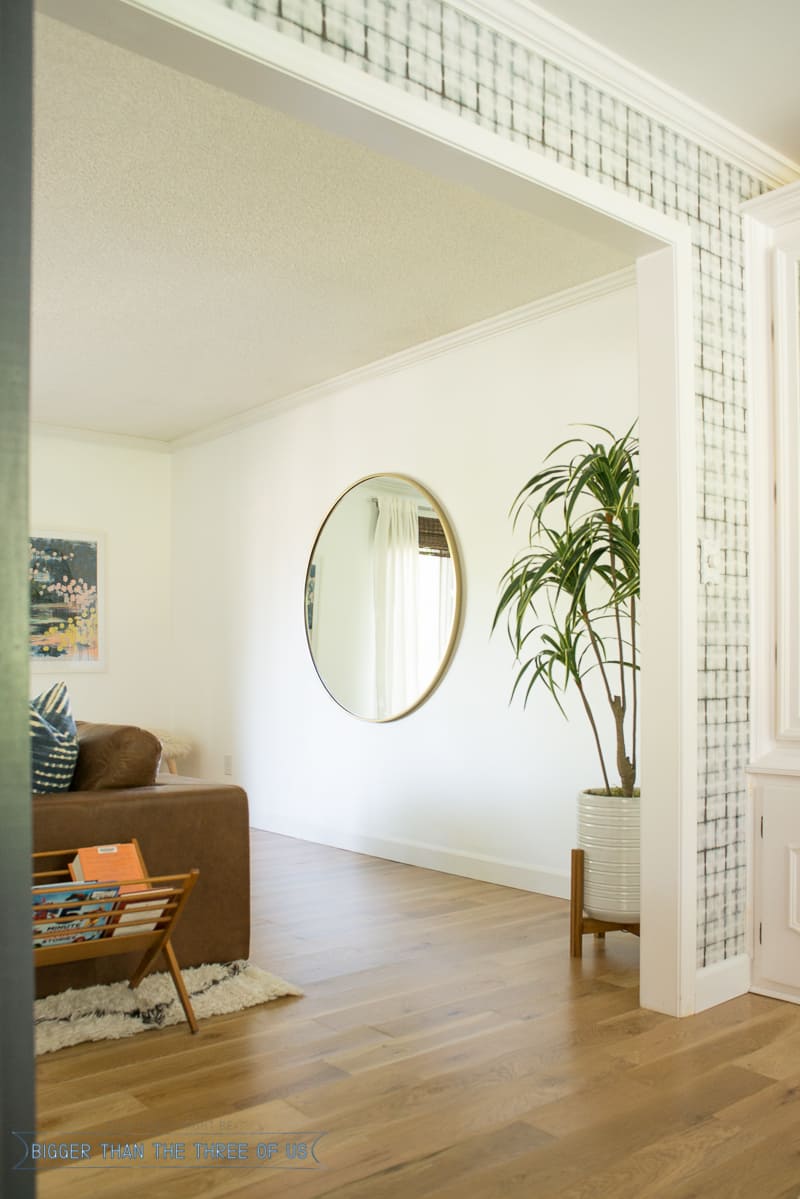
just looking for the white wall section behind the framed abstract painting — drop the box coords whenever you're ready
[30,430,173,728]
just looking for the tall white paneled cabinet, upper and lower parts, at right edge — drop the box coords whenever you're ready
[744,183,800,1002]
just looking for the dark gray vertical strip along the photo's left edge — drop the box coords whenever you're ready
[0,0,36,1199]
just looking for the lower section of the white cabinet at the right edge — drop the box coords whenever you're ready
[752,776,800,1004]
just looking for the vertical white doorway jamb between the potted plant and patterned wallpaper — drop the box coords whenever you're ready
[637,241,697,1016]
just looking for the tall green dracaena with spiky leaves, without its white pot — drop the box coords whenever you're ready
[492,424,639,795]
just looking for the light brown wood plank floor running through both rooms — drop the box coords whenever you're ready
[37,833,800,1199]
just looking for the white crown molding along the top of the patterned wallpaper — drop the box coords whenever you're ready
[446,0,800,187]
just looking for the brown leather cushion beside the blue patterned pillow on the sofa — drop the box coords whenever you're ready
[71,721,161,791]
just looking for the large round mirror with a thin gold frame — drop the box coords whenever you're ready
[305,475,462,722]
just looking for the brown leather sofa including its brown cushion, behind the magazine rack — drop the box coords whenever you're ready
[32,723,249,995]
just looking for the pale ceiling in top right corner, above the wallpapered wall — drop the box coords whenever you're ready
[539,0,800,162]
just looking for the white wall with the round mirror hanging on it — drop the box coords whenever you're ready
[174,289,637,894]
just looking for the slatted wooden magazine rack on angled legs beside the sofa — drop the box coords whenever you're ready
[32,842,199,1032]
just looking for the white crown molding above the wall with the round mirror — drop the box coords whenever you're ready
[169,266,636,450]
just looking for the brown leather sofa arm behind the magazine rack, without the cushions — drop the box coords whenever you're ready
[34,783,249,989]
